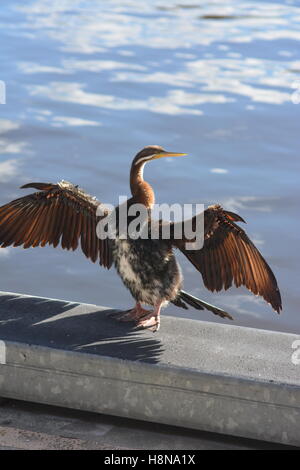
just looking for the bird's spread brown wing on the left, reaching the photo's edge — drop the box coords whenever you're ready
[0,181,112,268]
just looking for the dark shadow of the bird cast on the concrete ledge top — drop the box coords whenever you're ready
[0,294,163,363]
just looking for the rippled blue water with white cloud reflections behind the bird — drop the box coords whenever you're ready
[0,0,300,332]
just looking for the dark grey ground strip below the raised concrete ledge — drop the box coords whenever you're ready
[0,400,296,450]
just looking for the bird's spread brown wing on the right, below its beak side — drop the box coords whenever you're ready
[173,205,282,313]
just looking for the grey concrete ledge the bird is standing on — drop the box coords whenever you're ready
[0,292,300,446]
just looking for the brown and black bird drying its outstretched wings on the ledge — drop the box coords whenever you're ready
[0,145,282,331]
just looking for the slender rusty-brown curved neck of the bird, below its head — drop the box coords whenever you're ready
[130,162,155,209]
